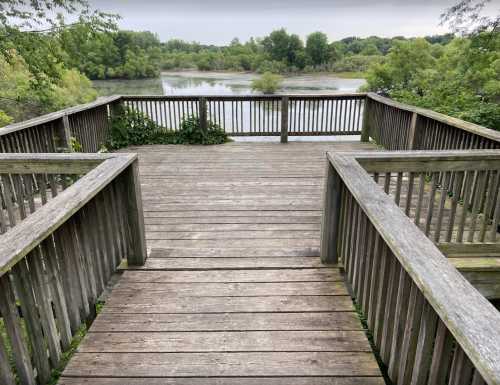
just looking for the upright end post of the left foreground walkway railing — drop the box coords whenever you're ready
[125,159,147,266]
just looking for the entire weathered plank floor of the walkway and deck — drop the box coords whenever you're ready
[60,142,384,385]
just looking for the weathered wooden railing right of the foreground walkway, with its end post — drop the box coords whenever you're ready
[321,151,500,384]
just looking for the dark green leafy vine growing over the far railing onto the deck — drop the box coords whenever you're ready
[106,107,228,149]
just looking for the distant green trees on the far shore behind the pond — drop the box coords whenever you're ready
[158,28,458,73]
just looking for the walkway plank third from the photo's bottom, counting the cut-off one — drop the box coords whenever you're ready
[78,330,371,353]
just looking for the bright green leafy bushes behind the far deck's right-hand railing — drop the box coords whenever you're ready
[366,32,500,130]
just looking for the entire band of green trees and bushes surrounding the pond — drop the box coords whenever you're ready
[0,0,500,129]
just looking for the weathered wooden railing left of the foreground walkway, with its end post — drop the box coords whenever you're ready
[0,154,146,385]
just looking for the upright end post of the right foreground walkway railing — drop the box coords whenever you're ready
[320,161,341,263]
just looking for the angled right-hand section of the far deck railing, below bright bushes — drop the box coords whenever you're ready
[362,93,500,150]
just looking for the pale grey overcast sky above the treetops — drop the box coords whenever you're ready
[91,0,500,44]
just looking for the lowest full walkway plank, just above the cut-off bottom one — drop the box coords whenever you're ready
[64,352,379,377]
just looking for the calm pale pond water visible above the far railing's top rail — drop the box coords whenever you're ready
[94,71,365,95]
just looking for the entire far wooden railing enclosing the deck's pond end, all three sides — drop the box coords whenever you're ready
[0,93,500,152]
